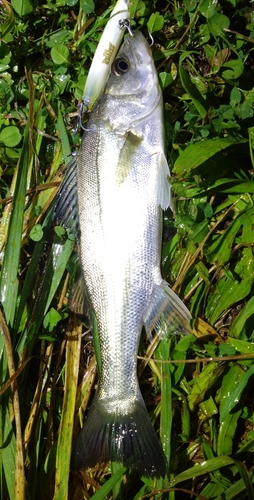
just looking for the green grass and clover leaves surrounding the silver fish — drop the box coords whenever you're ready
[0,0,254,500]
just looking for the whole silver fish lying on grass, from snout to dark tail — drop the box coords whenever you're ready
[57,31,190,477]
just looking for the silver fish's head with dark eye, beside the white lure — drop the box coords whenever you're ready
[97,31,161,135]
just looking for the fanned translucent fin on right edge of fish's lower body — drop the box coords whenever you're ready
[144,280,191,338]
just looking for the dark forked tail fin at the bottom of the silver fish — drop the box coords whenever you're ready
[74,398,166,477]
